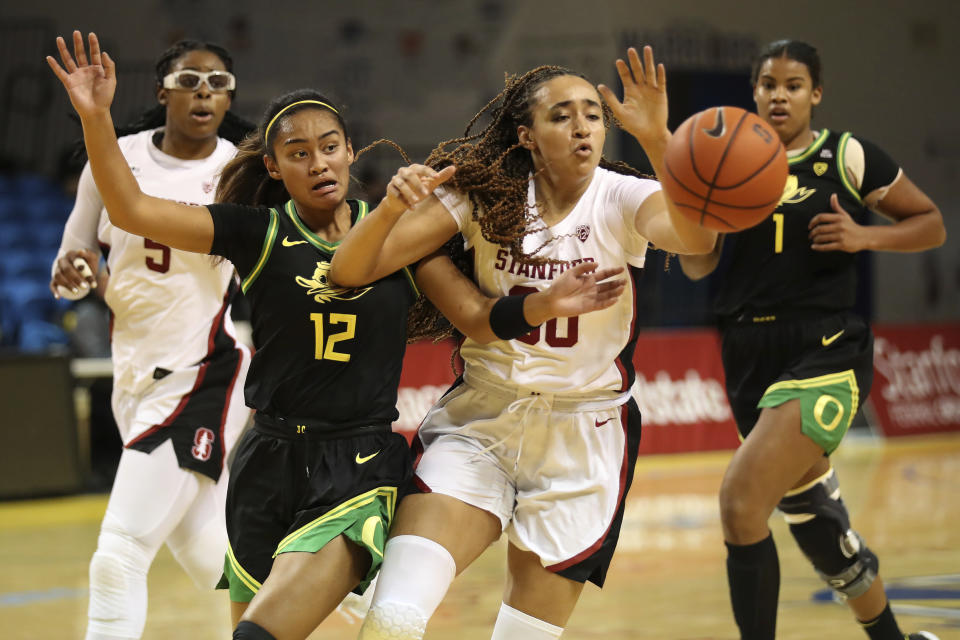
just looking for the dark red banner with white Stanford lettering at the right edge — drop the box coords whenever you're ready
[868,324,960,436]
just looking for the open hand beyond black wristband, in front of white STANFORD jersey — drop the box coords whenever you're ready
[544,262,627,318]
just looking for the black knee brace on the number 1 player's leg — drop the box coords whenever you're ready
[779,469,879,598]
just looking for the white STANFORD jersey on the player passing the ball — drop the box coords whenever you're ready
[437,168,660,395]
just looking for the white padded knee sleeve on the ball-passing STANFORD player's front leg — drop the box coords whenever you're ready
[359,535,457,640]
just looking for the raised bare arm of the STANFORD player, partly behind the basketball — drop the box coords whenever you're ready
[597,46,717,254]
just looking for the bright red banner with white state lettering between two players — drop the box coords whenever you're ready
[633,329,740,455]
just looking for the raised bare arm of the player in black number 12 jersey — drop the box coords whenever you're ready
[47,31,213,253]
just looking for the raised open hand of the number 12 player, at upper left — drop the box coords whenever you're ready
[47,31,117,119]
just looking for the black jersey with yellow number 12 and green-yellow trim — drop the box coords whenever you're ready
[208,200,416,429]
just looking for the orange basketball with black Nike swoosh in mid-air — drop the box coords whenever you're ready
[661,107,788,233]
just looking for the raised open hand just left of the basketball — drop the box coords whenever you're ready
[597,45,668,147]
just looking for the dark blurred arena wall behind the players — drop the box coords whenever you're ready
[0,0,960,324]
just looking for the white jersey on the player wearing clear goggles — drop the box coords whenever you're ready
[96,131,236,393]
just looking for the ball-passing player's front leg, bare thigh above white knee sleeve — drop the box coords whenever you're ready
[360,493,503,640]
